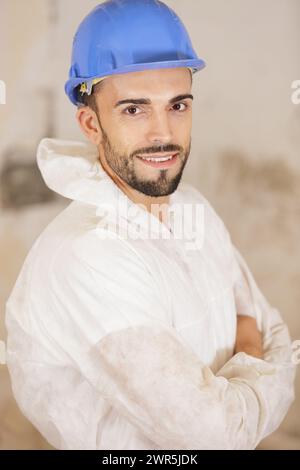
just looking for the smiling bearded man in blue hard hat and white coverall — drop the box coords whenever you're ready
[6,0,294,449]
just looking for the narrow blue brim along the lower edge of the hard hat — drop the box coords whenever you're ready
[65,59,206,106]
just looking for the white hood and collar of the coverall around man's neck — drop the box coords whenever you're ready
[37,138,188,237]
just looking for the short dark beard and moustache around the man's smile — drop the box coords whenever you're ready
[97,113,191,197]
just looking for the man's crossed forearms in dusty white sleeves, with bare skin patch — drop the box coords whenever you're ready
[86,246,295,449]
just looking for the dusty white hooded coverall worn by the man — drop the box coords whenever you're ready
[6,139,295,449]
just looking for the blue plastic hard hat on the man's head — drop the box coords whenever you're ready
[65,0,206,105]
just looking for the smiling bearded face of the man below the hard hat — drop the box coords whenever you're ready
[91,68,192,197]
